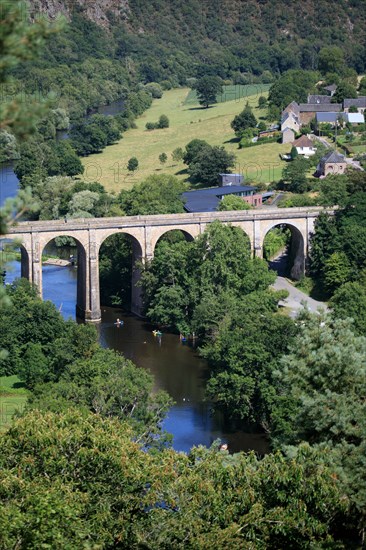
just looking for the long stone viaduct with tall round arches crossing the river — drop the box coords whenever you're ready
[2,208,323,321]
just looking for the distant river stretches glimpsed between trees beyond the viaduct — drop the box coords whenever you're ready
[0,99,124,206]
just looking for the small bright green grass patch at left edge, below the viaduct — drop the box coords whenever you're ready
[0,376,27,431]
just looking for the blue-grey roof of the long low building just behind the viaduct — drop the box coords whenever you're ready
[182,185,257,212]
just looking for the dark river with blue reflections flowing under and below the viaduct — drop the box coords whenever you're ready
[6,262,268,454]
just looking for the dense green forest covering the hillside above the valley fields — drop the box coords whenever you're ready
[7,0,366,122]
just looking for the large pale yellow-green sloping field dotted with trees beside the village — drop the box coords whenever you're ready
[83,87,289,192]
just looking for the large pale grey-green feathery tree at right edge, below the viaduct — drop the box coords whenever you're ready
[278,313,366,536]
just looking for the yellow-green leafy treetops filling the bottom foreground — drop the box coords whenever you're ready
[0,410,347,550]
